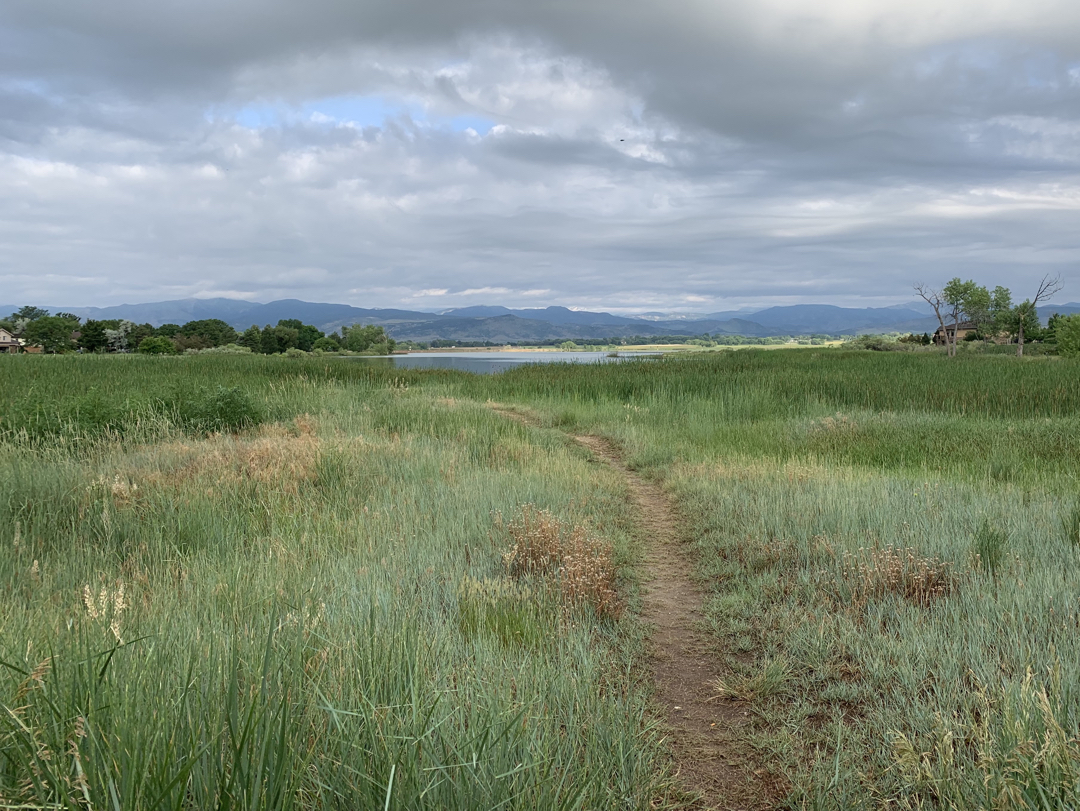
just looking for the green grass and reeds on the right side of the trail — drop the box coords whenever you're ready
[476,351,1080,810]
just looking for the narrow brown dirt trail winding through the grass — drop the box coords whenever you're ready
[492,406,777,811]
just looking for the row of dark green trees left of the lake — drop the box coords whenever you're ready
[0,307,395,355]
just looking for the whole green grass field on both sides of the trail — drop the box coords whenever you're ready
[0,348,1080,809]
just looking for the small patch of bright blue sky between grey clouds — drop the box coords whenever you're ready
[231,95,495,135]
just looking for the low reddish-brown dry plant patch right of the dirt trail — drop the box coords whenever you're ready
[841,546,956,607]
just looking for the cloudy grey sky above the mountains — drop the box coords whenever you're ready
[0,0,1080,313]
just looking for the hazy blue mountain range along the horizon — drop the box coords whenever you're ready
[0,298,1080,343]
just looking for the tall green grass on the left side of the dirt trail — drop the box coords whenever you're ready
[0,359,666,809]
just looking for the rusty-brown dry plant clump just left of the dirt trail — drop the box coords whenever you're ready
[503,504,622,618]
